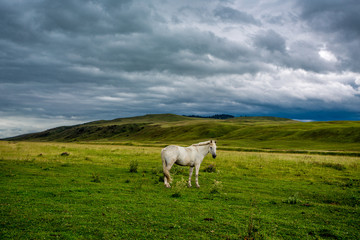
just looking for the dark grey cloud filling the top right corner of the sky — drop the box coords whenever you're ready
[298,0,360,71]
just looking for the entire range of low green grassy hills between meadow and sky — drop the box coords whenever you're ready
[7,114,360,151]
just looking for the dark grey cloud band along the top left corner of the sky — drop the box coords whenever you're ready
[0,0,150,39]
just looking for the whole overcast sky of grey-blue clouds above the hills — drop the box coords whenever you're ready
[0,0,360,138]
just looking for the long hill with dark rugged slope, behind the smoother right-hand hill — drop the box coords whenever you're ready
[6,114,295,142]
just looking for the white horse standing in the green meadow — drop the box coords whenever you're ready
[161,140,216,187]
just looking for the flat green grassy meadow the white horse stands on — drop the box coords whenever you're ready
[0,141,360,239]
